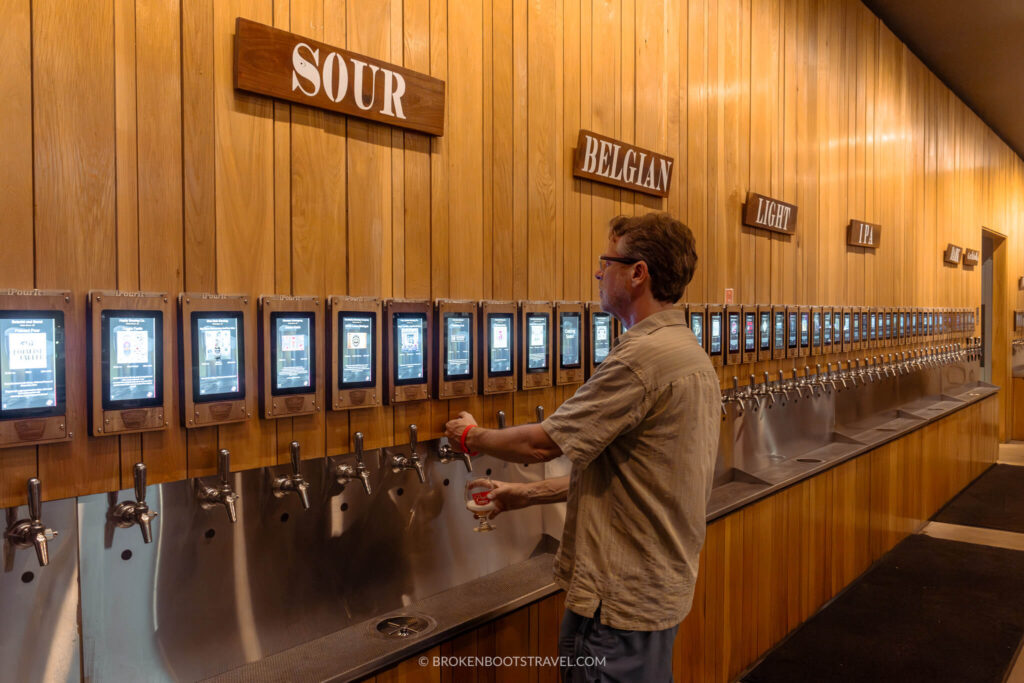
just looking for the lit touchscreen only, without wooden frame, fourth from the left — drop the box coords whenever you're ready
[270,312,316,395]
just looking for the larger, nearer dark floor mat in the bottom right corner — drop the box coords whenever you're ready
[742,536,1024,683]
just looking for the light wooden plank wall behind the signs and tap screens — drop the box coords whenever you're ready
[0,0,1024,507]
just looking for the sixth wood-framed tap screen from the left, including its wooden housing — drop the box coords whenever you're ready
[383,299,434,403]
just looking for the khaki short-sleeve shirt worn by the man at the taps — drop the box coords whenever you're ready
[542,309,722,631]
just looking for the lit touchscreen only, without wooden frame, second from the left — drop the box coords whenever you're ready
[99,310,164,410]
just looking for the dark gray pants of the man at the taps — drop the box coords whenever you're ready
[558,605,679,683]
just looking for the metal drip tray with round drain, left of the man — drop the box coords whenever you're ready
[206,553,558,683]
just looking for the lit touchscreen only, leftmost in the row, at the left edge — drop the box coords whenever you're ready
[0,311,65,418]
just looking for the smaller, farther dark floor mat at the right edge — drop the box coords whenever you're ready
[934,465,1024,533]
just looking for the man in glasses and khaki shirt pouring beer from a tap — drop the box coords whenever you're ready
[445,214,721,681]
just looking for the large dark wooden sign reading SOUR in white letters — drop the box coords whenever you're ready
[234,16,444,135]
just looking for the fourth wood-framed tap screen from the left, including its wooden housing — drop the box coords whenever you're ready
[259,296,324,420]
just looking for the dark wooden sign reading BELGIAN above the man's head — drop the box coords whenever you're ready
[572,130,673,197]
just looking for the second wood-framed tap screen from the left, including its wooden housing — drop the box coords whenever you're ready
[87,291,174,436]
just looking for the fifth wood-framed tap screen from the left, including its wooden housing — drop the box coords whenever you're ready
[324,296,383,411]
